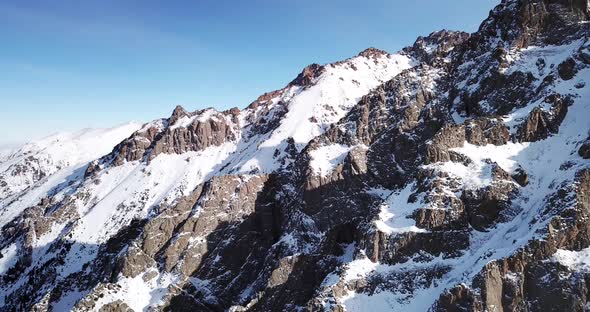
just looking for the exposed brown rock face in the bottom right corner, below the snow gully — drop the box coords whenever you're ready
[436,170,590,311]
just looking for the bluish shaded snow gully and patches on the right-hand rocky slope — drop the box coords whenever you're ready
[330,41,590,311]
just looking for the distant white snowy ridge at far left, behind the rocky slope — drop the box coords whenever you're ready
[0,123,141,226]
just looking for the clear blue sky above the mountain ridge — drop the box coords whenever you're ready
[0,0,499,144]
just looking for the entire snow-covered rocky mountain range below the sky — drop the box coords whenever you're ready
[0,0,590,311]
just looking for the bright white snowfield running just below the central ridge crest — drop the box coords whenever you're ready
[228,54,416,173]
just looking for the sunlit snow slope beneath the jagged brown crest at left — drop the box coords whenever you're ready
[70,143,235,243]
